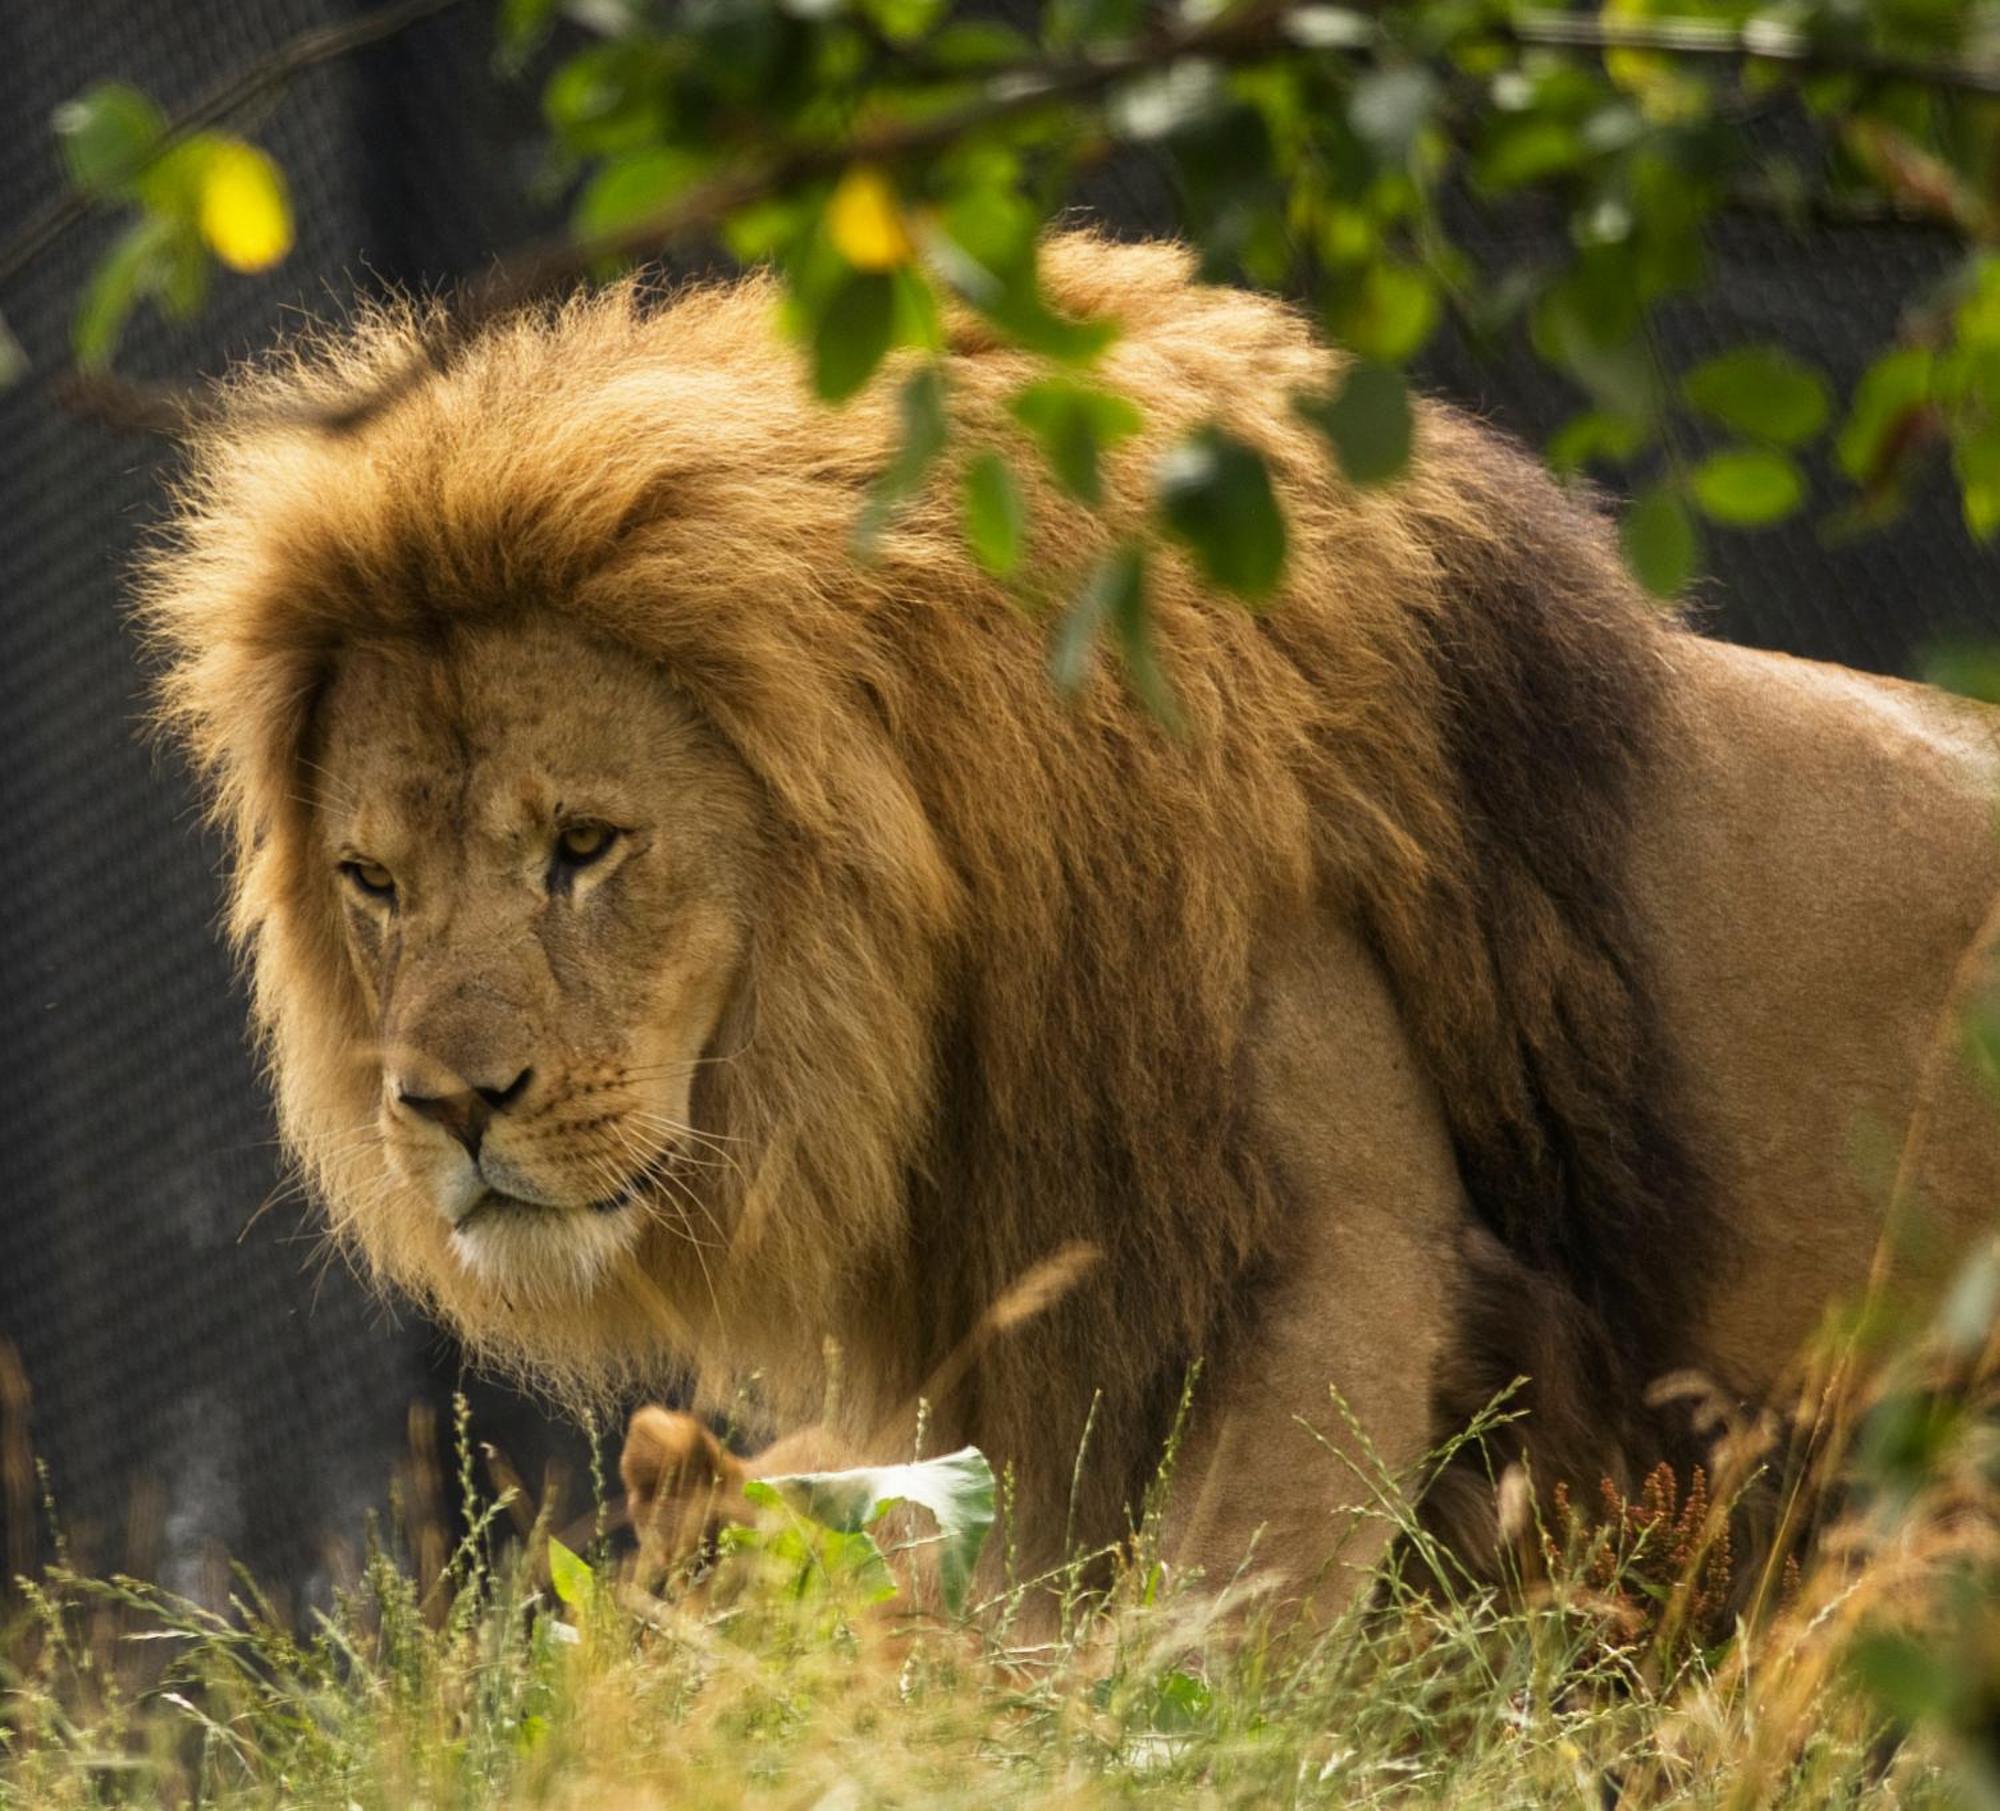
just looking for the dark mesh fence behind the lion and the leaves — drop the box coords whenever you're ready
[0,0,2000,1595]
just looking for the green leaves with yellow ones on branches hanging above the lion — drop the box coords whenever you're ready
[11,0,2000,674]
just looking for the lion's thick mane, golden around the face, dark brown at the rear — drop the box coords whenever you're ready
[142,236,1716,1527]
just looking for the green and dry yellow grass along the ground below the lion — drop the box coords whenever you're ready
[0,1251,2000,1811]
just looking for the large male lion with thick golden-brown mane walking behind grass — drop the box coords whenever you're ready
[144,236,2000,1605]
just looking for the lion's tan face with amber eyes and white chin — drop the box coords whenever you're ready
[308,622,758,1297]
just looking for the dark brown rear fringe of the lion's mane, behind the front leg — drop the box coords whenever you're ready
[1398,422,1726,1527]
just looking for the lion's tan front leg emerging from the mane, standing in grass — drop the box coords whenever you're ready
[1164,921,1466,1619]
